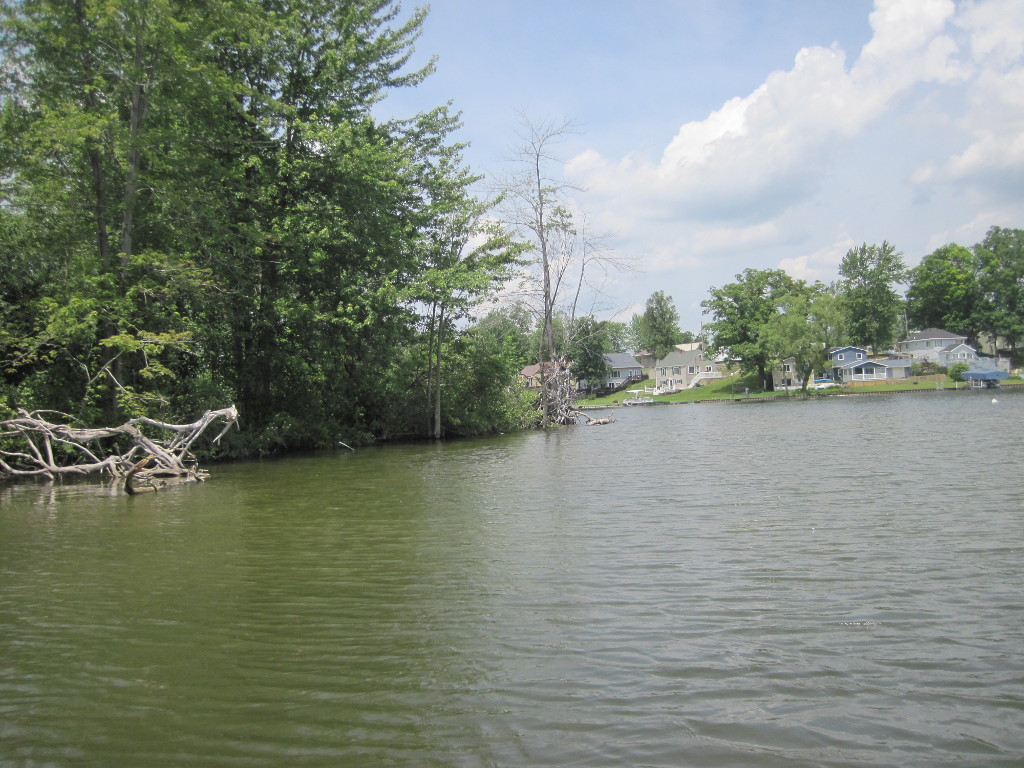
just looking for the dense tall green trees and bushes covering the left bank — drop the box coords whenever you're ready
[0,0,522,453]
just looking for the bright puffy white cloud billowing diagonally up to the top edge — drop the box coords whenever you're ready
[570,0,963,236]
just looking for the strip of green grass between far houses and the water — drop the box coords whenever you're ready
[577,373,1024,411]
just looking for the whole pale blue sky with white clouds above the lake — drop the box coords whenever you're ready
[383,0,1024,332]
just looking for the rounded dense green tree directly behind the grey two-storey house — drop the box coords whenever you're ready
[906,243,978,338]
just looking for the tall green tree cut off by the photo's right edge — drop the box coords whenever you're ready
[974,226,1024,347]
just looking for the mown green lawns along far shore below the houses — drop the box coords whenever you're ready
[577,374,1021,408]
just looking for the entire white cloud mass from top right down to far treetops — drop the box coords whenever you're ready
[568,0,1024,327]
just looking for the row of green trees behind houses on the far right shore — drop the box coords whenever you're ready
[701,226,1024,390]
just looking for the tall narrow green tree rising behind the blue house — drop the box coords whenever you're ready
[839,242,906,352]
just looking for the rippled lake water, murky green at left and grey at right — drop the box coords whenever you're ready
[0,392,1024,768]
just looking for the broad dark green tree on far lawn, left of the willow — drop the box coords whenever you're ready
[700,268,802,391]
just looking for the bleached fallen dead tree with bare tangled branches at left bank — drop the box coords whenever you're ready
[0,406,239,493]
